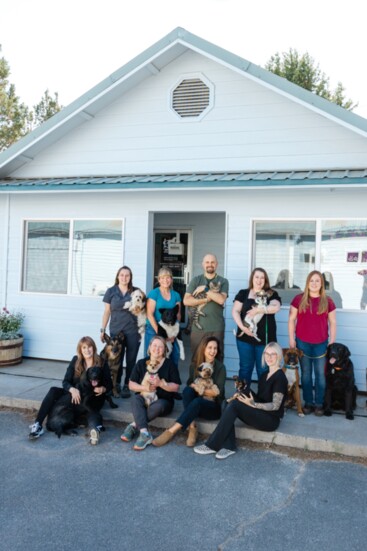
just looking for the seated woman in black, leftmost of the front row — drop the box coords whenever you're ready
[29,337,112,445]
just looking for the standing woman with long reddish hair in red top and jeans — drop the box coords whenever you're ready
[288,270,336,416]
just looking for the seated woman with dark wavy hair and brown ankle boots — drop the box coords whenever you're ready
[153,336,226,447]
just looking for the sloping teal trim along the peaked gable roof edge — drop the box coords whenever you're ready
[0,27,367,175]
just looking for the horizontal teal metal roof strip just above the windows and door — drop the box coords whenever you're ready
[0,169,367,193]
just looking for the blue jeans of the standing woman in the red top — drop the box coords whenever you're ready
[296,338,327,407]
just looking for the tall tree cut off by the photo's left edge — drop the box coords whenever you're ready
[0,47,30,151]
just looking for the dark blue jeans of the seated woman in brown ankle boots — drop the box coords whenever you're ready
[176,386,222,430]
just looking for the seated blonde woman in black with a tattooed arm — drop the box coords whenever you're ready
[194,342,287,459]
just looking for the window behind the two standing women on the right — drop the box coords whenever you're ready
[253,220,367,309]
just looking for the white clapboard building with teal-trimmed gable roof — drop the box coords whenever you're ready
[0,28,367,391]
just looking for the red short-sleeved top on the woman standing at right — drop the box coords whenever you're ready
[291,294,336,344]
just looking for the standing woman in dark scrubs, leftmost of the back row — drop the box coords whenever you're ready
[101,266,145,398]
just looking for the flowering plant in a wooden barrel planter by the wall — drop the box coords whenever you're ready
[0,307,25,366]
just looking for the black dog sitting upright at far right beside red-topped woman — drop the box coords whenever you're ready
[324,342,357,420]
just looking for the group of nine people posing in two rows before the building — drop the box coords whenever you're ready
[29,254,336,459]
